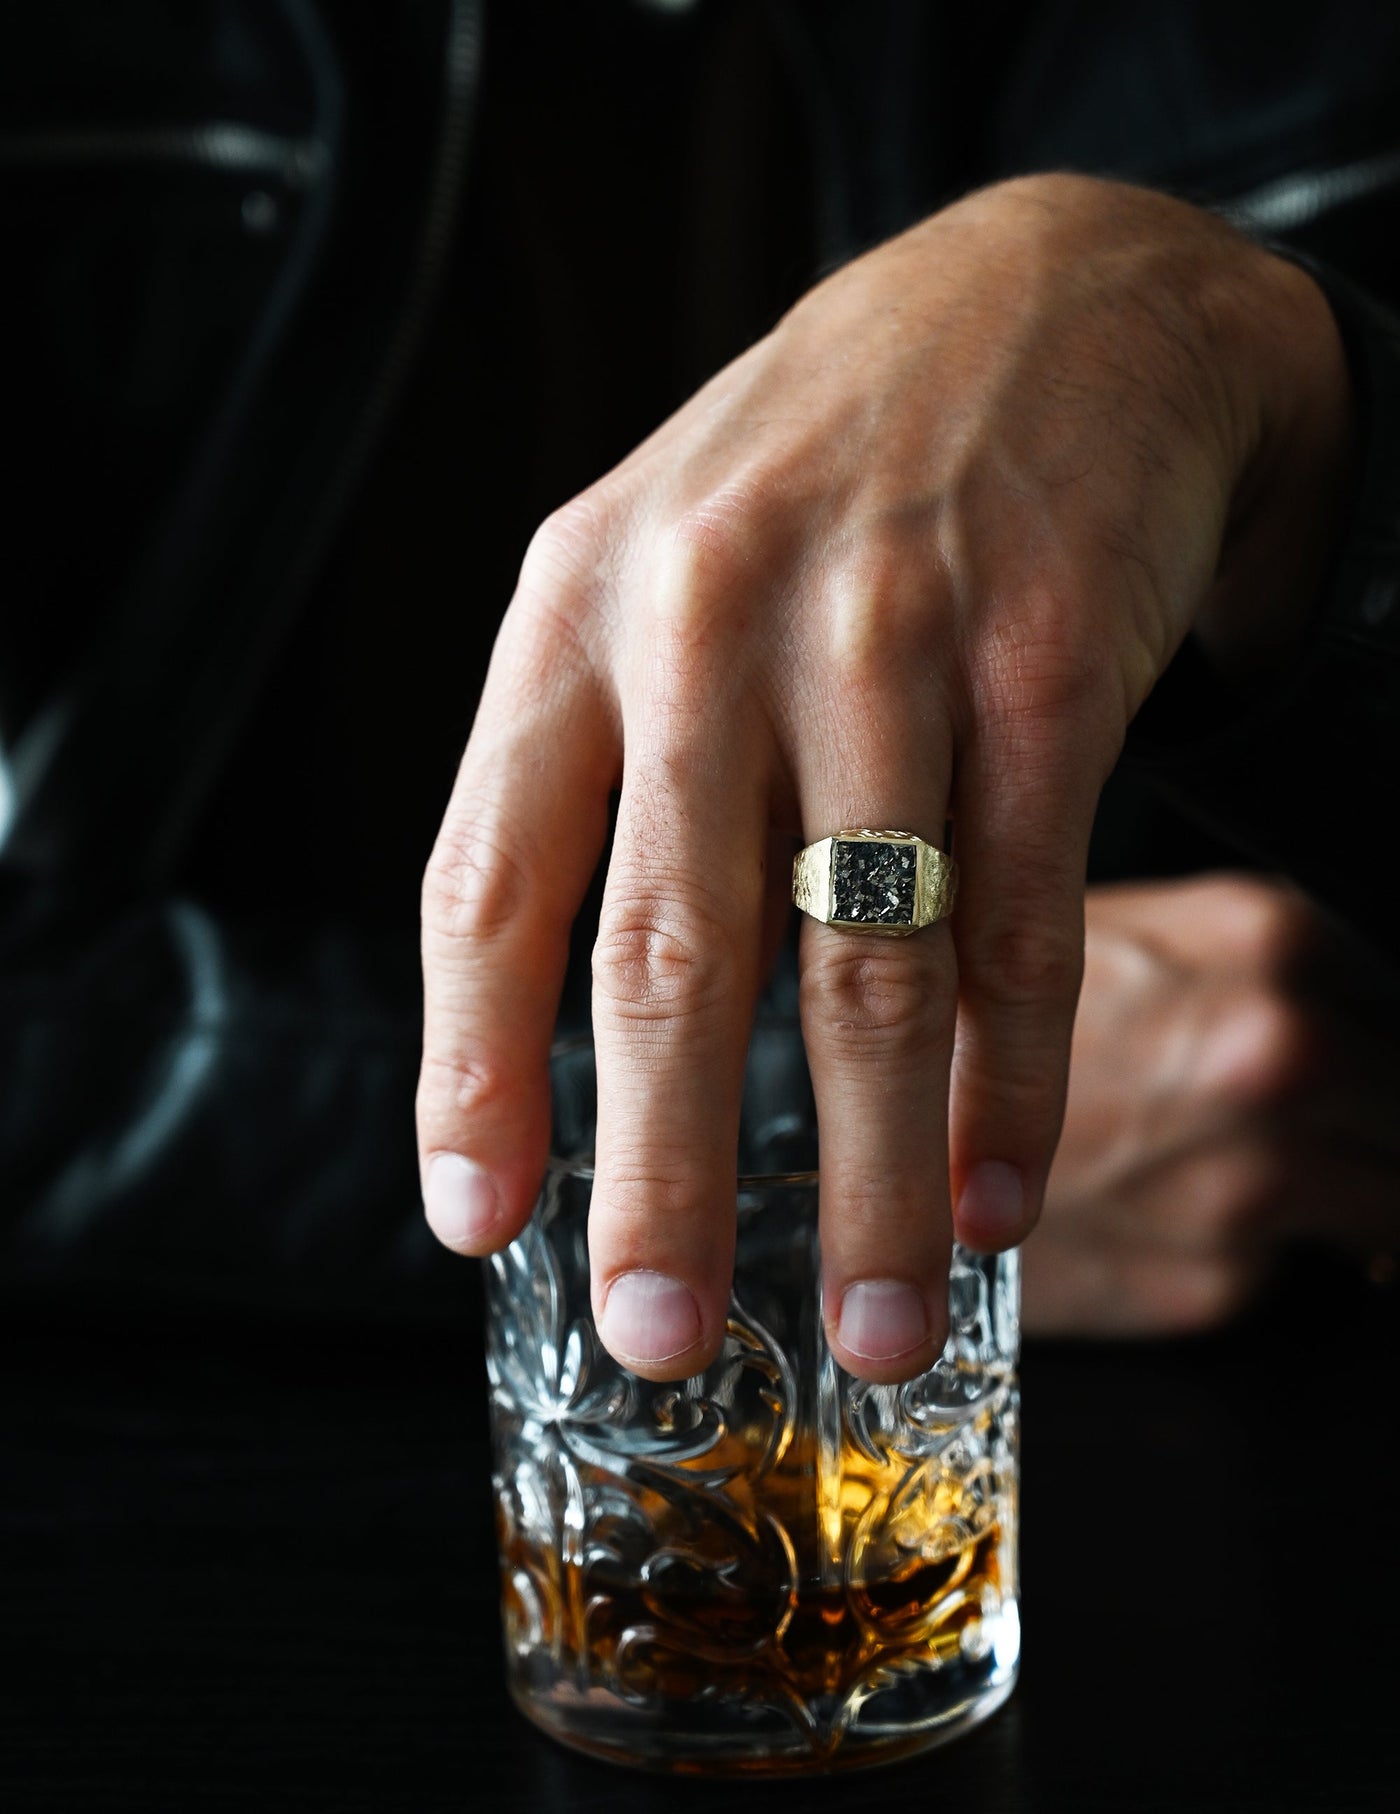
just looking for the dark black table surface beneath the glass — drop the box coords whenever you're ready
[0,1268,1400,1814]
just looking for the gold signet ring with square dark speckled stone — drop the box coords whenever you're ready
[792,831,958,938]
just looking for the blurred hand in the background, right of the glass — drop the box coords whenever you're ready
[1023,876,1400,1335]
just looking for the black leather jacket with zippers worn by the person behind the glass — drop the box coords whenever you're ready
[0,0,1400,1312]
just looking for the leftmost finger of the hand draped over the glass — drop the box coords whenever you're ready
[417,602,617,1253]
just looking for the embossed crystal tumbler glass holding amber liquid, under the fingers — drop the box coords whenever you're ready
[488,1025,1019,1774]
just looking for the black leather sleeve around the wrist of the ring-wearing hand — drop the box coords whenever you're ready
[1124,264,1400,956]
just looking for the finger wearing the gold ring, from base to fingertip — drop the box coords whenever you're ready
[800,688,958,1380]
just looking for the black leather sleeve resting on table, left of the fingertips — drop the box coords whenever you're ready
[0,874,479,1321]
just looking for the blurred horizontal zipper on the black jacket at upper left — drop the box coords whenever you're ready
[0,120,328,185]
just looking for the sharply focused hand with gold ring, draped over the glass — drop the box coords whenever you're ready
[419,176,1347,1380]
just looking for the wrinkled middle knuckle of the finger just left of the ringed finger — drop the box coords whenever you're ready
[593,882,738,1019]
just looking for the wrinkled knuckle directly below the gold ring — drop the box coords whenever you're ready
[802,934,950,1052]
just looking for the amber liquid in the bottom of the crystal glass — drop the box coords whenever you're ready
[501,1414,1006,1756]
